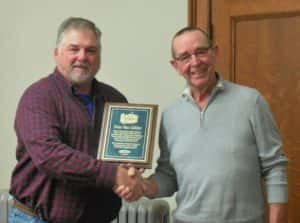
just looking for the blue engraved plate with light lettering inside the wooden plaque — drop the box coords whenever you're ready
[104,107,150,160]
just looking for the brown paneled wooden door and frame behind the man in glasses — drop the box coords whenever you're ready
[189,0,300,223]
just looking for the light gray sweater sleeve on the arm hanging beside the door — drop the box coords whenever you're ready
[251,94,288,203]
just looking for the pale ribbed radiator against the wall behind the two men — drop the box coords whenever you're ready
[0,190,170,223]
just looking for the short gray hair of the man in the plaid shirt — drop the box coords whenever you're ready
[56,17,101,48]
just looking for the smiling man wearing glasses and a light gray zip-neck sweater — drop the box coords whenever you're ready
[115,27,287,223]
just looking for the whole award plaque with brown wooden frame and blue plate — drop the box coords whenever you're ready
[97,103,158,169]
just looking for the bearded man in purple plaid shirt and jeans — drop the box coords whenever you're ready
[9,18,141,223]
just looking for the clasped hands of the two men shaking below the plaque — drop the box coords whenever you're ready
[113,164,158,202]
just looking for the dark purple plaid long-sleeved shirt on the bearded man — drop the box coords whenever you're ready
[10,70,126,223]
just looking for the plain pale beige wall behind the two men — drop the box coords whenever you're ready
[0,0,187,214]
